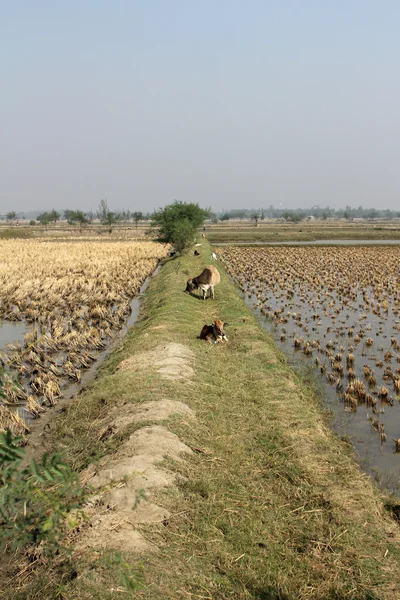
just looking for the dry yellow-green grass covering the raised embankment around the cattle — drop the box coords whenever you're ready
[7,244,400,600]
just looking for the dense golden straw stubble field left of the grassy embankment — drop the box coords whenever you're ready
[0,239,168,433]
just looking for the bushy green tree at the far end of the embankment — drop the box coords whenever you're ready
[151,200,210,252]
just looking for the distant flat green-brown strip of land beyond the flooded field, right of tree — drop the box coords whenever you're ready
[207,221,400,244]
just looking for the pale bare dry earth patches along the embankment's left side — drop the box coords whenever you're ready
[76,343,194,552]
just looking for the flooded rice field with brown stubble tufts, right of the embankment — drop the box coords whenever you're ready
[220,246,400,492]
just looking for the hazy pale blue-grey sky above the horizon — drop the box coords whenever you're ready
[0,0,400,212]
